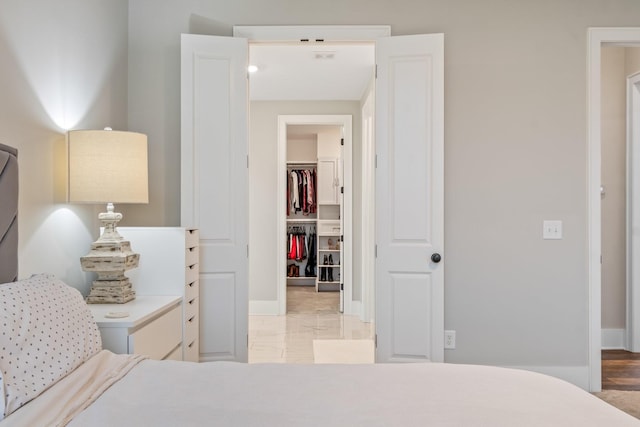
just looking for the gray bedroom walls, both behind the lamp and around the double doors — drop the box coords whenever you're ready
[0,0,640,382]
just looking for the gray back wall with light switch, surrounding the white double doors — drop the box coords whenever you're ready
[124,0,640,374]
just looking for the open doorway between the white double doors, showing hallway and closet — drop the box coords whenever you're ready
[249,43,375,361]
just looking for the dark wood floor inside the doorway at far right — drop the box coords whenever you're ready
[602,350,640,391]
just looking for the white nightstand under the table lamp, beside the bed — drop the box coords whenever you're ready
[87,296,182,360]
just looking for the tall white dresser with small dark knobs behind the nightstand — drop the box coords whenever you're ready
[118,227,200,362]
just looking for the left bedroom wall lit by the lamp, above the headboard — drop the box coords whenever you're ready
[0,0,128,293]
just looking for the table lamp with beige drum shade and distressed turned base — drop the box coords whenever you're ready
[67,128,149,304]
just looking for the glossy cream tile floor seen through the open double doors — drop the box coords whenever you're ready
[249,286,374,363]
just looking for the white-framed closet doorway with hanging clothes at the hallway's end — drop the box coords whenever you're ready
[278,115,353,314]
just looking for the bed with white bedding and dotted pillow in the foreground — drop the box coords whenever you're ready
[0,143,640,427]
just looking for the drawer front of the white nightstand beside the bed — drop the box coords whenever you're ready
[129,305,182,360]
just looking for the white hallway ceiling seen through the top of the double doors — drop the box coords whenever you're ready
[249,42,375,101]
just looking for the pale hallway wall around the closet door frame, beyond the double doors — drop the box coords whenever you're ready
[249,101,360,302]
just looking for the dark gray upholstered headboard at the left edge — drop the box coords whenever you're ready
[0,144,18,283]
